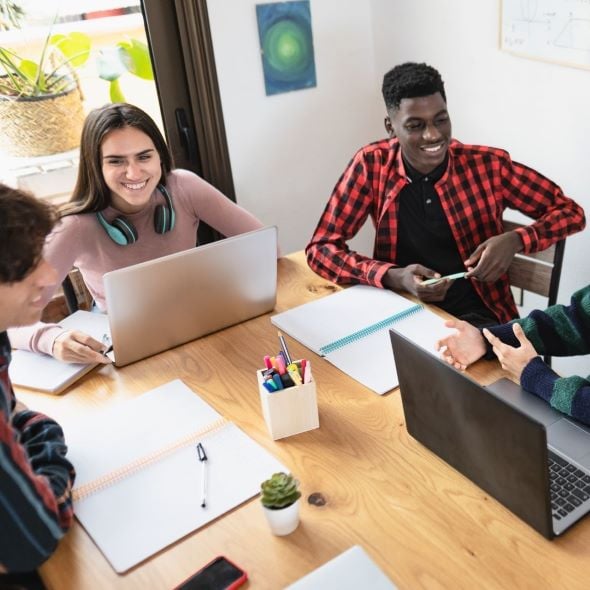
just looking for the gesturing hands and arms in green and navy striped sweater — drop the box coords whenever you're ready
[437,285,590,424]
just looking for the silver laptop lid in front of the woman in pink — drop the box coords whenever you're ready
[104,226,277,366]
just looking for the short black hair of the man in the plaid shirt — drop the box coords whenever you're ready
[381,62,447,110]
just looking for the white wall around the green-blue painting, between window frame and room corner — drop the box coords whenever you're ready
[208,0,384,253]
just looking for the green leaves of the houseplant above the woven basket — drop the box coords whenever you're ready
[0,32,154,102]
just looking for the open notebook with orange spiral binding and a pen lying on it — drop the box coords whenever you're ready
[63,380,286,573]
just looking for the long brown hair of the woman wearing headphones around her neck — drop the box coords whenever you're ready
[60,103,173,217]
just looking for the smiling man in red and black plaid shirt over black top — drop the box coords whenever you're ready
[306,63,585,326]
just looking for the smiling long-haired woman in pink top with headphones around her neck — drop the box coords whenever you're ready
[11,104,262,363]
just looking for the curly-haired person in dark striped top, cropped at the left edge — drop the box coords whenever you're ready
[0,184,74,586]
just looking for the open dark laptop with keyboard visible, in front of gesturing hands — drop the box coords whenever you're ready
[390,330,590,539]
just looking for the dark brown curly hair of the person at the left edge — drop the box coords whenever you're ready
[0,184,57,283]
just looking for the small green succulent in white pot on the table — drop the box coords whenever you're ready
[260,472,301,536]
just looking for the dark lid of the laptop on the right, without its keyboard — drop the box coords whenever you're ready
[390,330,553,538]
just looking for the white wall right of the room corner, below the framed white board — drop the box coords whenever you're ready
[371,0,590,374]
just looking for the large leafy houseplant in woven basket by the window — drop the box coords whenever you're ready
[0,27,154,156]
